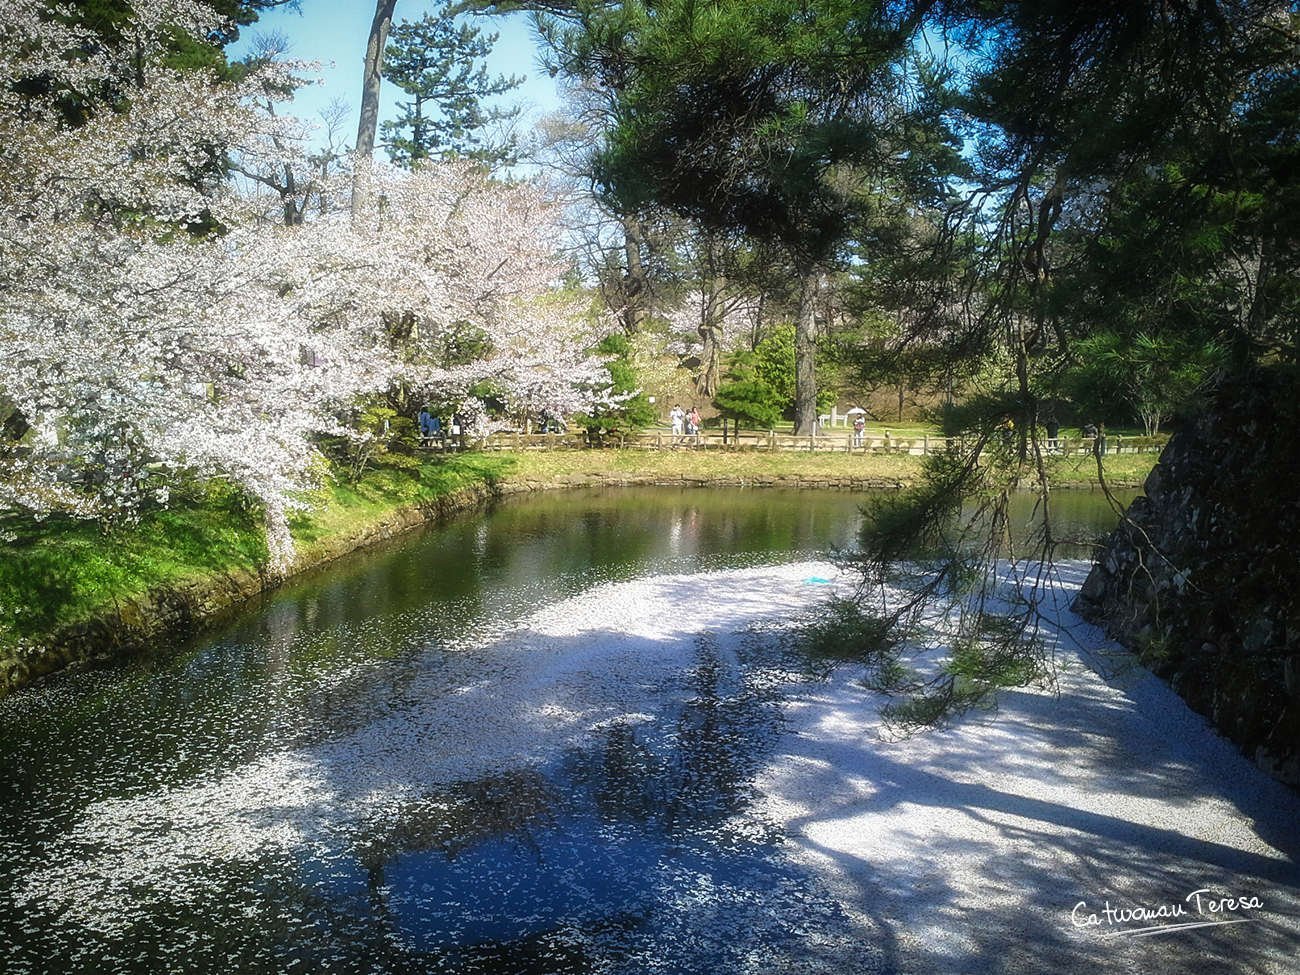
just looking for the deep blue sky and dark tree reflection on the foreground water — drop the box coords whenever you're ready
[343,641,806,971]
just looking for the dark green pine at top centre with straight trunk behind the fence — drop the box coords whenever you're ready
[553,0,946,433]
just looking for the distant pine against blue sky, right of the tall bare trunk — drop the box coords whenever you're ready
[381,4,524,166]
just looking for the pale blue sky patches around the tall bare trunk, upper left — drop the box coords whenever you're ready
[231,0,560,144]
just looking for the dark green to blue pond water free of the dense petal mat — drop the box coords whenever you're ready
[0,489,1133,972]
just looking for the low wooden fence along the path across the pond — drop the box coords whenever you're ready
[421,430,1169,456]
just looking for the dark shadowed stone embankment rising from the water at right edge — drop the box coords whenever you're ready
[1076,373,1300,787]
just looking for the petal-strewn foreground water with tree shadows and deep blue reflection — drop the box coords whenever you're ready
[5,571,1300,975]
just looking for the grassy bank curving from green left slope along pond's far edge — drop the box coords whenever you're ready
[0,450,1154,657]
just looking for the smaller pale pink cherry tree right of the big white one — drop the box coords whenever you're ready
[317,163,610,430]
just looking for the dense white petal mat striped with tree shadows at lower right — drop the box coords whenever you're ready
[762,629,1300,972]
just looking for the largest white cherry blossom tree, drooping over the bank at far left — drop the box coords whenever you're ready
[0,0,371,560]
